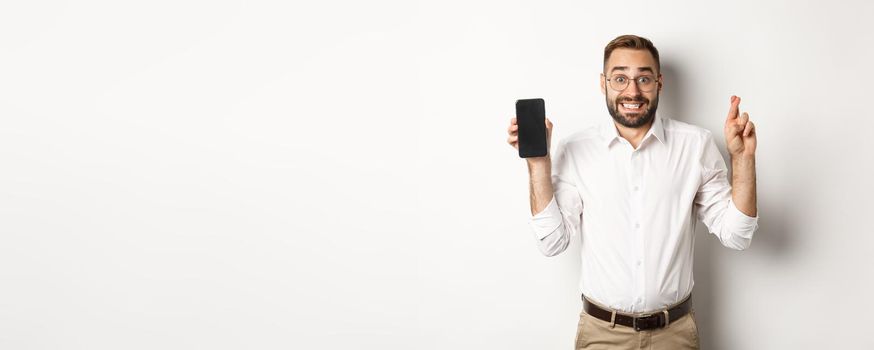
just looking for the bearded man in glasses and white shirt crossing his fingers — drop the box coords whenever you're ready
[508,35,758,349]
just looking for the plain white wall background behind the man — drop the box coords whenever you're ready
[0,1,874,349]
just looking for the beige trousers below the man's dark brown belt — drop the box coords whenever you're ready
[575,308,700,350]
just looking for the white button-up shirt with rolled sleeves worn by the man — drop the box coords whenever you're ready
[530,116,758,313]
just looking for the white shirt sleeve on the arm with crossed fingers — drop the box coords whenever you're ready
[694,132,759,250]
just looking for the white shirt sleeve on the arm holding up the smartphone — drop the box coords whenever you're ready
[529,142,583,256]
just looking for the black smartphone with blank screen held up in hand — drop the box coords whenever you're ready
[516,98,549,158]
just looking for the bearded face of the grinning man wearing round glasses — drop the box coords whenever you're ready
[601,48,662,128]
